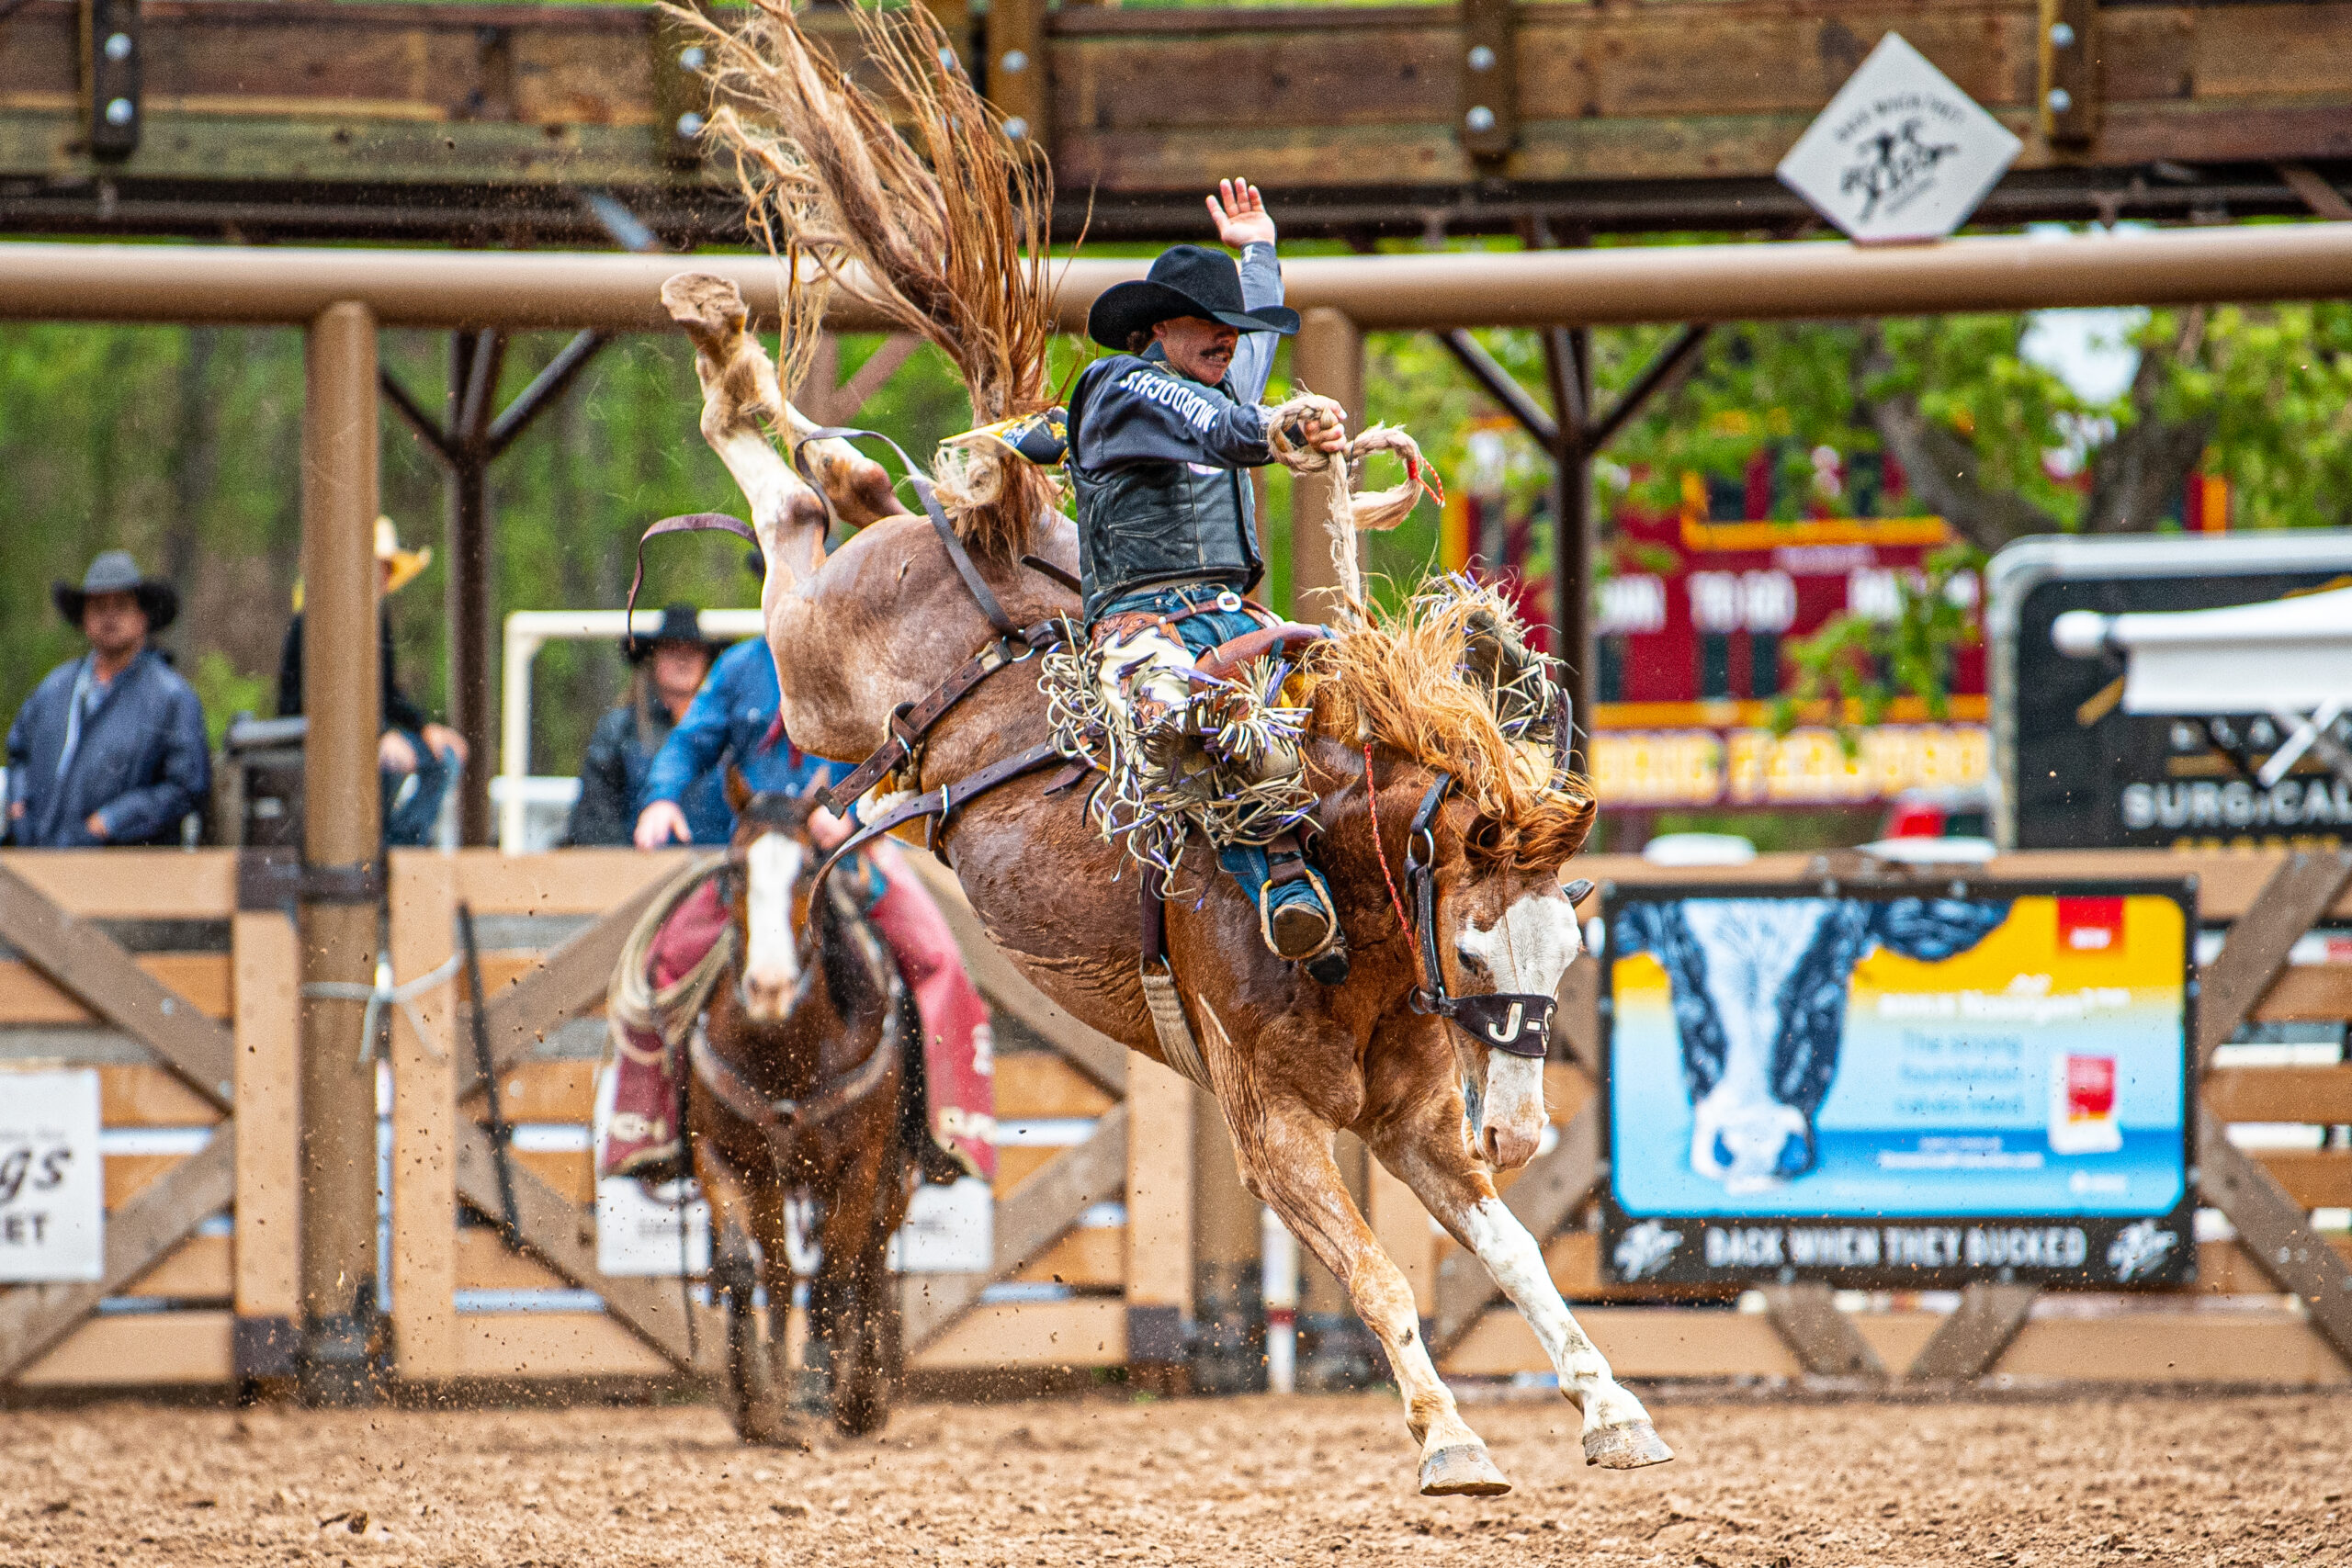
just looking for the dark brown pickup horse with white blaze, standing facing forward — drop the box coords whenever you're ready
[687,769,929,1443]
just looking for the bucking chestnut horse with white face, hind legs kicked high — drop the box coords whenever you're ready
[663,0,1672,1495]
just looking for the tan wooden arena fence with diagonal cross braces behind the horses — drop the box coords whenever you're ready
[0,851,2352,1389]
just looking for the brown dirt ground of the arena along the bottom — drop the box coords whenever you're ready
[0,1396,2352,1568]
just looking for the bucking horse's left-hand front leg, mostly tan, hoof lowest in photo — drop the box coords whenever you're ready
[1235,1105,1510,1497]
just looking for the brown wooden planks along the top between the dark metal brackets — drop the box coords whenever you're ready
[0,0,2352,211]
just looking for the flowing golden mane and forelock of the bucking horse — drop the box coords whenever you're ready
[1306,579,1597,870]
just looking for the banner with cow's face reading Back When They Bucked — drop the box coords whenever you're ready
[1601,882,2197,1288]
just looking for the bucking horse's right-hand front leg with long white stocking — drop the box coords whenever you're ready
[1369,1093,1675,1470]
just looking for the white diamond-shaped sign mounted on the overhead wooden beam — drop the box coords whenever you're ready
[1778,33,2025,243]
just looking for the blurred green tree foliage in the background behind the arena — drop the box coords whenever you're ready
[0,263,2352,799]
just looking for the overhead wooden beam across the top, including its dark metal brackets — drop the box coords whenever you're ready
[0,0,2352,244]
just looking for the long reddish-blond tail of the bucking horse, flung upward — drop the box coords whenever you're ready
[663,0,1056,558]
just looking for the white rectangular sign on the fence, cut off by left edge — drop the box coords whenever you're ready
[0,1067,106,1281]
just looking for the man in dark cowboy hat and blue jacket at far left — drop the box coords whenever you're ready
[7,550,211,849]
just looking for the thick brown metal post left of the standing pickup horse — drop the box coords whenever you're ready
[299,301,383,1404]
